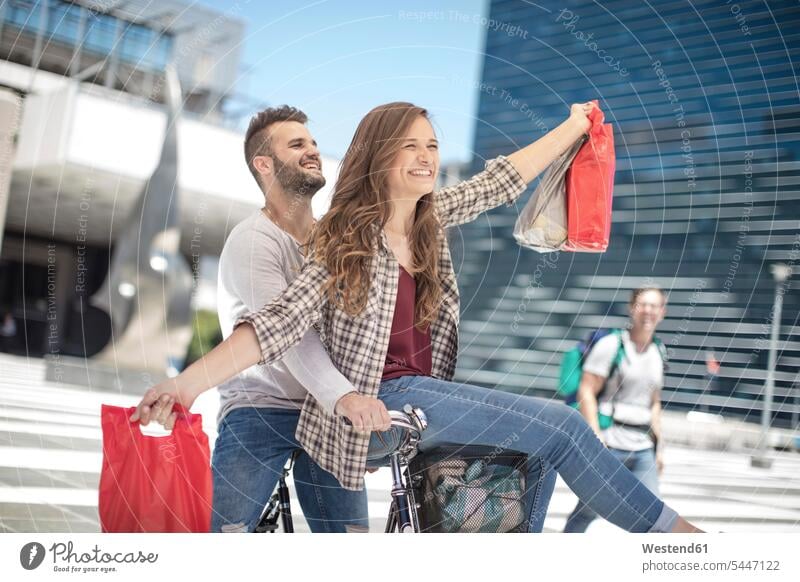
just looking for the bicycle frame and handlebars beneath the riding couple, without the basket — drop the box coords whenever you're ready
[255,404,428,533]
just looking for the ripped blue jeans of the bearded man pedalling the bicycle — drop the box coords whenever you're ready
[211,407,369,533]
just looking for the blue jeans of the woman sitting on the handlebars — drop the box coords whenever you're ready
[378,376,678,532]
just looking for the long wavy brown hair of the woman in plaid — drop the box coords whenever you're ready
[309,102,444,329]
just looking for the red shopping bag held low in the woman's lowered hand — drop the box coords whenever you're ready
[99,404,211,533]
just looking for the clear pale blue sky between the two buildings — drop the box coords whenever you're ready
[199,0,488,163]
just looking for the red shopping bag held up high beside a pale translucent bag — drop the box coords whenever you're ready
[562,99,616,252]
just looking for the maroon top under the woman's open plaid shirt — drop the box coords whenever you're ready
[382,266,433,380]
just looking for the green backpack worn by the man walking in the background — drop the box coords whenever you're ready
[558,329,667,430]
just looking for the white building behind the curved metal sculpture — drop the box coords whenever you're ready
[0,0,337,355]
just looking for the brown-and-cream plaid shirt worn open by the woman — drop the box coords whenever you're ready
[236,156,526,490]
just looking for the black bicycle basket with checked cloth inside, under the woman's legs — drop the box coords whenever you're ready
[409,446,527,533]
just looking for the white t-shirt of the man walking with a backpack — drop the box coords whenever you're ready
[583,330,664,451]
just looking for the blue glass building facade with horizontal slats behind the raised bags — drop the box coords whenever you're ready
[452,0,800,426]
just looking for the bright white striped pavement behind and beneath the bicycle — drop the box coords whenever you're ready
[0,355,800,534]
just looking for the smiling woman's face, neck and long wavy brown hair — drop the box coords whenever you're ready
[310,102,441,325]
